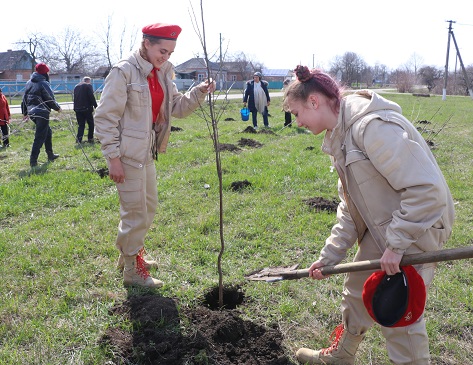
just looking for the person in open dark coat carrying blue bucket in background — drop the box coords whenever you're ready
[243,72,271,129]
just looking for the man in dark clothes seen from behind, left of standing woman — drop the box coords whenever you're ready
[74,76,97,143]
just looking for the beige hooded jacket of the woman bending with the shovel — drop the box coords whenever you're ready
[319,91,454,265]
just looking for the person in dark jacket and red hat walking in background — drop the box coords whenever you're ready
[21,63,61,167]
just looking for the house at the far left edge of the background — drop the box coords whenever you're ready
[0,49,34,81]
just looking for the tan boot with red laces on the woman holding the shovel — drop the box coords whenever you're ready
[296,324,365,365]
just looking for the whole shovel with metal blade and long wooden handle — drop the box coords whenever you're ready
[245,246,473,283]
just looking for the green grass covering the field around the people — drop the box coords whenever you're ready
[0,94,473,365]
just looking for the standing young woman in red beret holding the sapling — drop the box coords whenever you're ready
[95,23,215,287]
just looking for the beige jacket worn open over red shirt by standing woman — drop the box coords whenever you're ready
[95,51,207,168]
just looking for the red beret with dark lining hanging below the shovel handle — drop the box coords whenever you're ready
[362,266,427,327]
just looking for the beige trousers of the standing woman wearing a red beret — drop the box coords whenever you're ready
[116,159,158,256]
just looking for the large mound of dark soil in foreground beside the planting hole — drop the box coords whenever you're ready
[101,294,293,365]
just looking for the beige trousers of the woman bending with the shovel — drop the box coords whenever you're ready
[341,232,436,365]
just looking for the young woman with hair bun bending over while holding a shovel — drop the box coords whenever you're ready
[283,66,454,365]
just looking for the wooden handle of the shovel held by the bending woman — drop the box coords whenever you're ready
[279,246,473,280]
